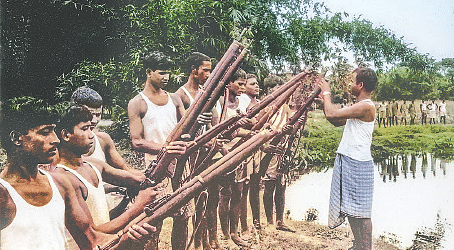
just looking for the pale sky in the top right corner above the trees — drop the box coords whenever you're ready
[319,0,454,61]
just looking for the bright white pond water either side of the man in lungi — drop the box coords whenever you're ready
[286,154,454,249]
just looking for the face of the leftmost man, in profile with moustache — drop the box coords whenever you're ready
[21,124,60,164]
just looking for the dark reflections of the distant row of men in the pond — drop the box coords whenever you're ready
[377,153,448,183]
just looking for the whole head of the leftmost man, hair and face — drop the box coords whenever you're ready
[0,96,59,164]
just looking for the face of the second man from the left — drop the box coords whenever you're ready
[68,121,94,155]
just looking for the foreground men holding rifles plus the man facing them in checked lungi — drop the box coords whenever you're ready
[0,47,376,249]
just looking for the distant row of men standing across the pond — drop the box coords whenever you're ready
[377,100,447,127]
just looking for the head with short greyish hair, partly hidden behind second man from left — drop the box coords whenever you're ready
[71,86,102,129]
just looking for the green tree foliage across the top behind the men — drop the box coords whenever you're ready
[2,0,440,109]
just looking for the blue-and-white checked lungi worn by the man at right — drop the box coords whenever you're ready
[328,154,374,228]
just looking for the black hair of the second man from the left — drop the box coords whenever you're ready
[55,105,93,139]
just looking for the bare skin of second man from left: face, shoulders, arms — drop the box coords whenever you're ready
[55,121,161,233]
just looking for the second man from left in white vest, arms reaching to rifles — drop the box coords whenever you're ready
[54,106,163,249]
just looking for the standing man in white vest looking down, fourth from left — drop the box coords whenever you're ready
[128,52,189,249]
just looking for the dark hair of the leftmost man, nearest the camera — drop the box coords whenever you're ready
[0,96,59,154]
